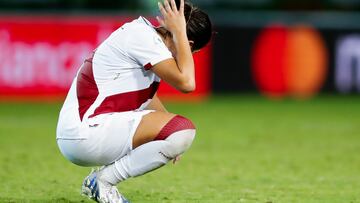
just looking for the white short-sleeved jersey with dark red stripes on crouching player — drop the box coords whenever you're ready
[57,17,172,139]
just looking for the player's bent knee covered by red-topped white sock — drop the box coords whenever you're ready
[155,115,196,158]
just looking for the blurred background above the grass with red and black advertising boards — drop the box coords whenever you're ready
[0,0,360,99]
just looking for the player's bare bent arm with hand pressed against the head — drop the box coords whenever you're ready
[152,0,195,93]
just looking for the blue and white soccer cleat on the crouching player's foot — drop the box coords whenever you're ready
[81,171,130,203]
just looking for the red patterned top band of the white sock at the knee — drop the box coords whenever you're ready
[154,115,195,140]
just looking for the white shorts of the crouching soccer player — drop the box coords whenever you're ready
[57,110,153,166]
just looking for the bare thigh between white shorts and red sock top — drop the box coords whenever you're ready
[133,111,176,149]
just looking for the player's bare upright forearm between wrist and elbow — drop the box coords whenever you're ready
[173,31,195,92]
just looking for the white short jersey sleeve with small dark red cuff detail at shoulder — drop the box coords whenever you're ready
[127,26,173,70]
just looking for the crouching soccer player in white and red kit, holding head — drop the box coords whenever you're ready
[57,0,212,203]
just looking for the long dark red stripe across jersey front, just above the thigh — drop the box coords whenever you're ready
[89,82,159,118]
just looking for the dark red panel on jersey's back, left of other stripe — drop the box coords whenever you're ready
[76,53,99,120]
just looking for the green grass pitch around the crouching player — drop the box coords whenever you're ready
[0,96,360,203]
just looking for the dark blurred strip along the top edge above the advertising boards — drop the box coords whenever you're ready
[0,0,360,12]
